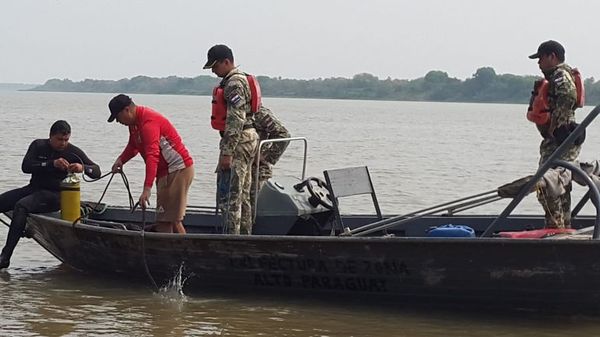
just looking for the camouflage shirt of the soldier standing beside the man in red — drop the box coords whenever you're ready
[220,68,254,156]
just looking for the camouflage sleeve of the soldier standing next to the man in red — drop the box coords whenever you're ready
[220,76,250,156]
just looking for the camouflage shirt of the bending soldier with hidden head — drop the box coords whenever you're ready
[254,106,290,165]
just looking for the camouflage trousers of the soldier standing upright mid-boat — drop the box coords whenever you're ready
[217,129,258,234]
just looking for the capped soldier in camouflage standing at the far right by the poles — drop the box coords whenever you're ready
[529,40,581,228]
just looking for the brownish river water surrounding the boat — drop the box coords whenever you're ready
[0,91,600,336]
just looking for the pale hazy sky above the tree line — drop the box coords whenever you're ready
[0,0,600,84]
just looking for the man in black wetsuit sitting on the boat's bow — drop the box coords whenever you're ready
[0,120,101,269]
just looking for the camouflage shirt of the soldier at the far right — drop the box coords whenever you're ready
[544,63,577,128]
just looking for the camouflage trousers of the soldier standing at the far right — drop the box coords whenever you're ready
[537,139,581,228]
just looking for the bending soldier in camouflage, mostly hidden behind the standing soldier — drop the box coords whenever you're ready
[250,106,290,215]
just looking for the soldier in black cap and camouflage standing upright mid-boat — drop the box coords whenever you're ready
[204,45,258,234]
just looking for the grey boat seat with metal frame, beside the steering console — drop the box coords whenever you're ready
[323,166,383,235]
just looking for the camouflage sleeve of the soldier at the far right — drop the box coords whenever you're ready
[549,70,577,128]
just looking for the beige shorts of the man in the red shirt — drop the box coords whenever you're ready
[156,166,194,222]
